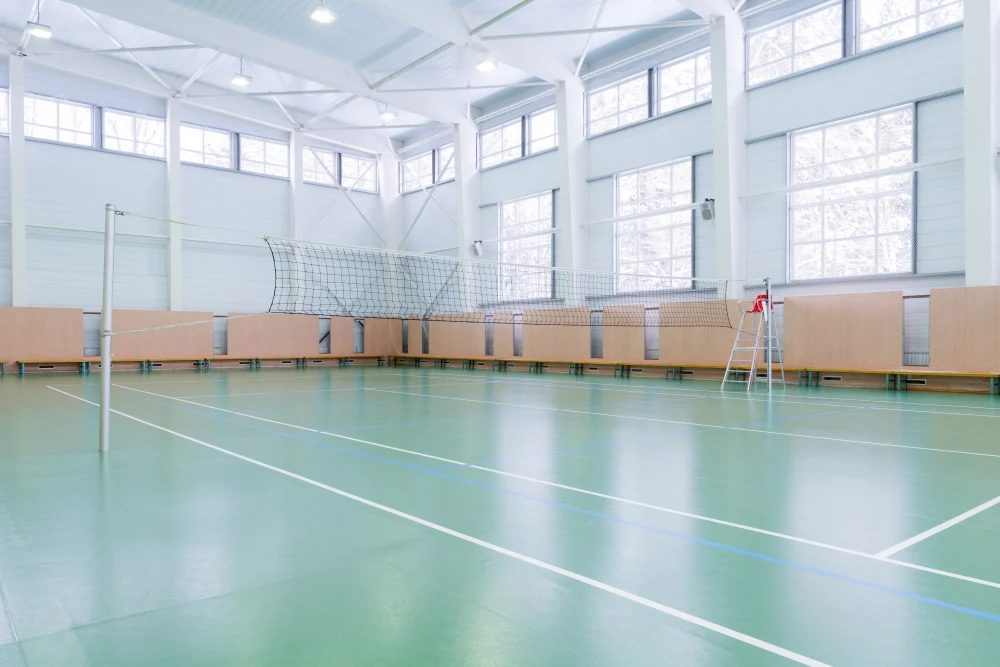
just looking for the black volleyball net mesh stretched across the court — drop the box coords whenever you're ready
[267,239,732,327]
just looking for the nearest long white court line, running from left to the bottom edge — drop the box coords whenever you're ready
[52,387,829,667]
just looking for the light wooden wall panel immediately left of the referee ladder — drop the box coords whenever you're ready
[660,300,740,368]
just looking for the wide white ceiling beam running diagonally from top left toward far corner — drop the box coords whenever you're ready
[68,0,462,122]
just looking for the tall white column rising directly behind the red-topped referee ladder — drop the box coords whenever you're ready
[709,10,748,298]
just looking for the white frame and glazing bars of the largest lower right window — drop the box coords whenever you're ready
[785,102,918,284]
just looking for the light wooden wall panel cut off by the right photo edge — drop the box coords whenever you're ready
[930,286,1000,373]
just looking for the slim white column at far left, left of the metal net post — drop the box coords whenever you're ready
[7,54,28,306]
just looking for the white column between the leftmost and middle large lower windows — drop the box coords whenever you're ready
[555,78,588,269]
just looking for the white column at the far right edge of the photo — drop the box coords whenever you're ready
[963,0,1000,285]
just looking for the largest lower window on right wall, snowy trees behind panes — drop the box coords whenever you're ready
[791,106,913,280]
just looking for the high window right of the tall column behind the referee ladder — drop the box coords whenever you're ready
[747,2,844,86]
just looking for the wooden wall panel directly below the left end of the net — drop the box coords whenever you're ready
[228,314,318,358]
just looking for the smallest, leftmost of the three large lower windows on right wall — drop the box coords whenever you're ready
[499,192,555,300]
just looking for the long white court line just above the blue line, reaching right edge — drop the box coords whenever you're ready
[99,385,1000,588]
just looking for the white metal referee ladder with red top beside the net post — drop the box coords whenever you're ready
[722,294,785,391]
